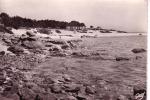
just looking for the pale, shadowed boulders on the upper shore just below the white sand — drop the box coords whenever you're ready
[2,31,82,56]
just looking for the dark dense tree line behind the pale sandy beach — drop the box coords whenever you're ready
[0,13,85,29]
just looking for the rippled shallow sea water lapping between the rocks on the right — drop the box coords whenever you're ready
[38,36,147,87]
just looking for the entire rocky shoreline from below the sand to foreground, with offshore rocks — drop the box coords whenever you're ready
[0,27,146,100]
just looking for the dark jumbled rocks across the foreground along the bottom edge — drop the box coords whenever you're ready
[0,67,146,100]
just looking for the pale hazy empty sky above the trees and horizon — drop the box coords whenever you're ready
[0,0,147,32]
